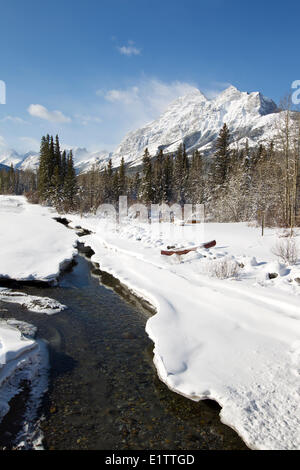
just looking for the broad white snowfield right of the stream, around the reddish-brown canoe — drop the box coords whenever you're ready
[68,212,300,449]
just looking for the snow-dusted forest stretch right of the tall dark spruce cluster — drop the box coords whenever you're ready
[78,111,300,226]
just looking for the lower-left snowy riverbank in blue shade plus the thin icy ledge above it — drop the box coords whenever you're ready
[0,288,66,449]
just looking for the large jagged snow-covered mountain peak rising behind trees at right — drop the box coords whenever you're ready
[112,86,279,166]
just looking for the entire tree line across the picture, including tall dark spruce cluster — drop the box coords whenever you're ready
[0,110,300,227]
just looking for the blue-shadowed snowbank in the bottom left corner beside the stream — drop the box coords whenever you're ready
[0,319,49,449]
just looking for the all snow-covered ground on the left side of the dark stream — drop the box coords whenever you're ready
[0,196,77,448]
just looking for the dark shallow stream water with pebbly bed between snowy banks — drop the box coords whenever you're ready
[0,256,246,450]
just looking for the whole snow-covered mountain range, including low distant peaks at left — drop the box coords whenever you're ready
[0,86,279,173]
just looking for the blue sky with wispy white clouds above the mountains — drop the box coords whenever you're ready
[0,0,300,152]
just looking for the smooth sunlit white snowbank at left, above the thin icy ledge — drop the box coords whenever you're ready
[0,196,77,282]
